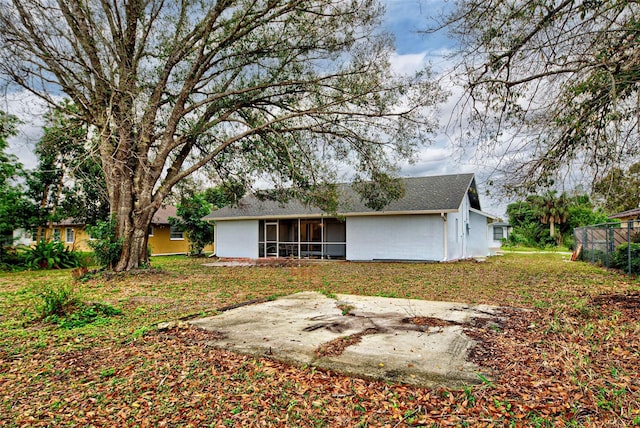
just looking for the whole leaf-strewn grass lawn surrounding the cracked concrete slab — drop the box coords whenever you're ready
[0,253,640,427]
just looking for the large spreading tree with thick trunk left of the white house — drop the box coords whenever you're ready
[0,0,440,270]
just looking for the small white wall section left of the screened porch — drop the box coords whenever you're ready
[215,220,258,259]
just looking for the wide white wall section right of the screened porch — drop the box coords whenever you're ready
[346,215,444,261]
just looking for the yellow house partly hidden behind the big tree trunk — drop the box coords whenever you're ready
[32,206,215,256]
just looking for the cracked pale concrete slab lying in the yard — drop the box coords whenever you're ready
[190,292,500,386]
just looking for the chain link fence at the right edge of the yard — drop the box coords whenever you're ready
[573,221,640,275]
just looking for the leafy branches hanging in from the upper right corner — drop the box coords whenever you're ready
[444,0,640,189]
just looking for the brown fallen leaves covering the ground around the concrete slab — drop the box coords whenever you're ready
[0,254,640,427]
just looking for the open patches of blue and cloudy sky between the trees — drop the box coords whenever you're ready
[0,0,508,218]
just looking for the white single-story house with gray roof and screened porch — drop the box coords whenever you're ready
[205,174,494,261]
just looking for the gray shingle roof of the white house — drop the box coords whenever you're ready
[205,174,480,220]
